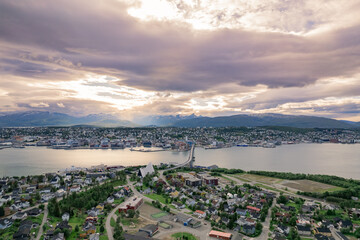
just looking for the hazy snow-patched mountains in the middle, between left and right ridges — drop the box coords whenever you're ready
[134,114,198,127]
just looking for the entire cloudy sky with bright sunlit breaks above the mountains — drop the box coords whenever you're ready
[0,0,360,121]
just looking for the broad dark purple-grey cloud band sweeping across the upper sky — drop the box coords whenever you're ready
[0,1,360,91]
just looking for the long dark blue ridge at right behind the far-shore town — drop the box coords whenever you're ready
[173,114,358,128]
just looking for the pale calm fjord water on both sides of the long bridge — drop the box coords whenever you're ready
[0,144,360,179]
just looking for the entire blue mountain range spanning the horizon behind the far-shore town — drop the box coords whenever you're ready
[0,111,360,129]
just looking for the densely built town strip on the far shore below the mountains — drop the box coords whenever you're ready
[0,127,360,151]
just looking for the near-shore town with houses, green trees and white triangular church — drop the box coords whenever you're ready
[0,151,360,240]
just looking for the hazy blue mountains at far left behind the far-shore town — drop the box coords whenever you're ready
[0,111,136,127]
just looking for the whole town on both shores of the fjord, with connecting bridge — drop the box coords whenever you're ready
[0,127,360,240]
